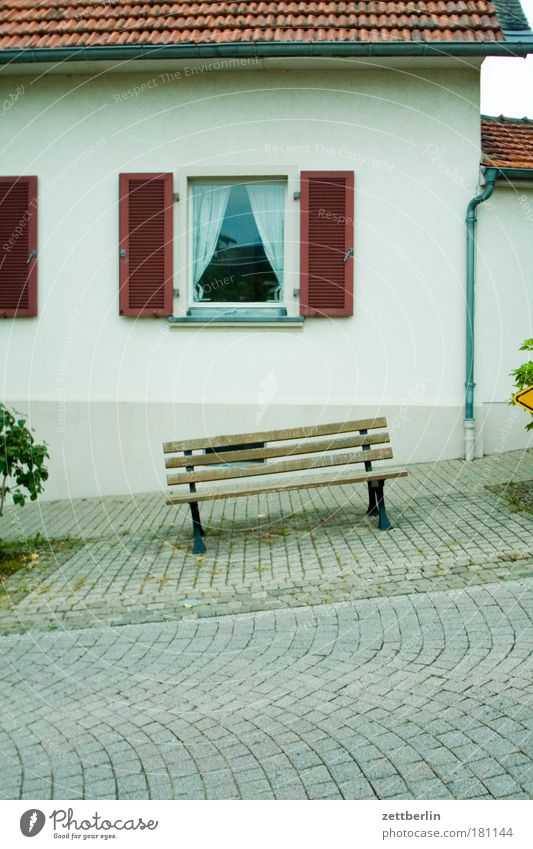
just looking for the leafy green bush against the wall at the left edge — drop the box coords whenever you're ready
[0,404,49,516]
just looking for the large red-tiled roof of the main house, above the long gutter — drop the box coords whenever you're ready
[0,0,531,50]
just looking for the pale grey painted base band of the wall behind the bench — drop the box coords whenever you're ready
[7,399,532,500]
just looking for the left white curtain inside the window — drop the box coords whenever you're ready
[192,183,231,285]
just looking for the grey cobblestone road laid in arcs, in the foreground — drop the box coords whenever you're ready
[0,579,533,799]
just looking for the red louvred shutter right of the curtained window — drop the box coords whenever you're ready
[300,171,354,316]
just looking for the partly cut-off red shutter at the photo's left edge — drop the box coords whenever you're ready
[0,177,37,318]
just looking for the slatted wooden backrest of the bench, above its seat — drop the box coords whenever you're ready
[163,418,392,491]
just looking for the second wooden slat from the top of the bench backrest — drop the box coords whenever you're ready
[165,431,390,469]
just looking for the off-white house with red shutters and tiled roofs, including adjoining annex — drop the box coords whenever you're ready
[0,0,533,497]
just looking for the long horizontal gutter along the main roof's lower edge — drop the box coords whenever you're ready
[0,39,533,65]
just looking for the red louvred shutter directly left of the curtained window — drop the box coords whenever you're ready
[119,174,173,316]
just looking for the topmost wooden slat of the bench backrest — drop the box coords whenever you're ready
[163,418,387,454]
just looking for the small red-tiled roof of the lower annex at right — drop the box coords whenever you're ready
[481,115,533,169]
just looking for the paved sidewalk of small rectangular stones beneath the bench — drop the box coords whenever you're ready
[0,450,533,633]
